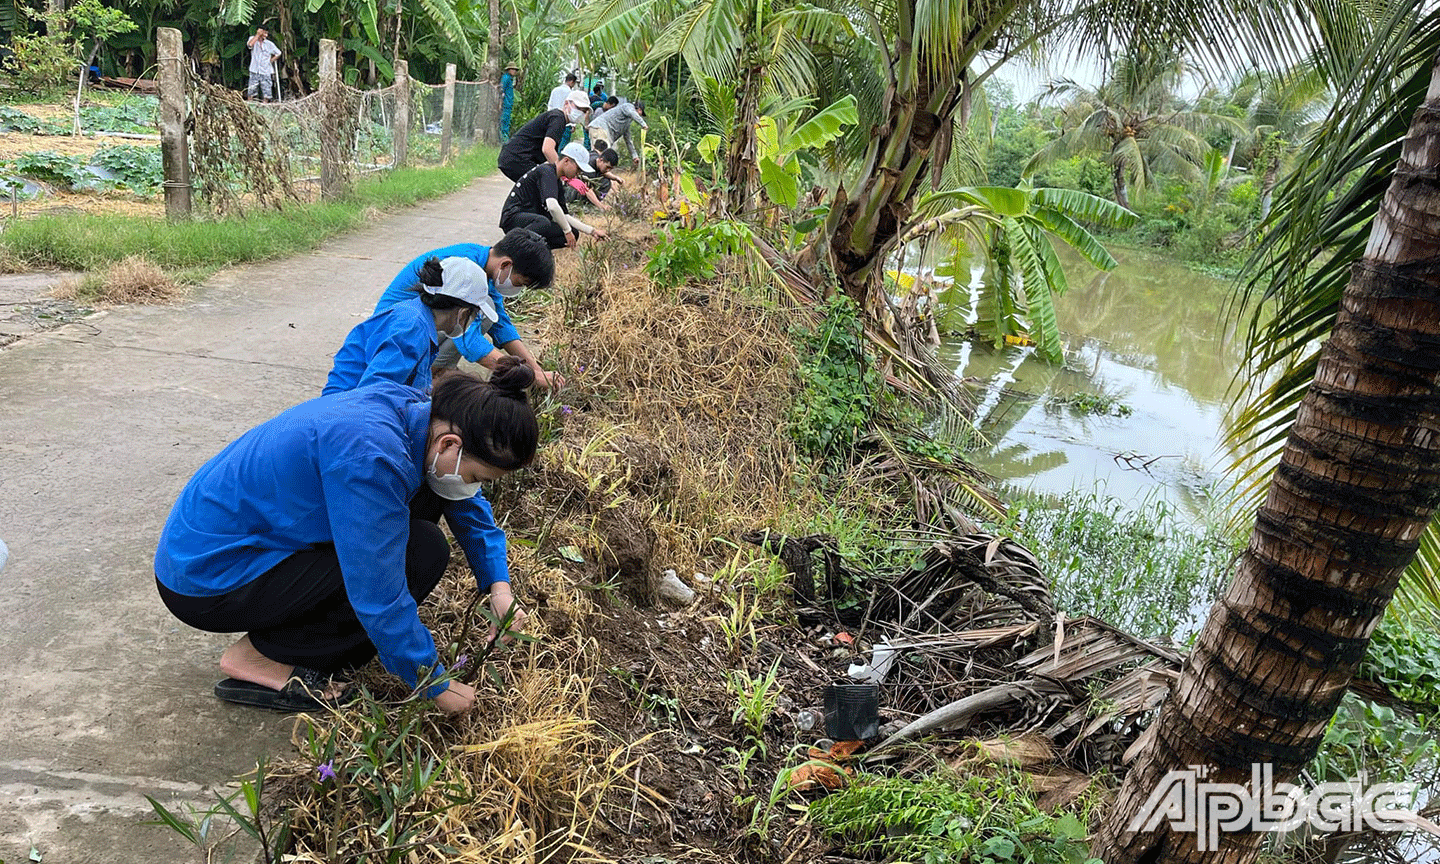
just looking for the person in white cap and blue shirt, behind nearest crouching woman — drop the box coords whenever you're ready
[321,256,498,396]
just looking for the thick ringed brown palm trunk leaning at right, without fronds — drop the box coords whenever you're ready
[1092,52,1440,864]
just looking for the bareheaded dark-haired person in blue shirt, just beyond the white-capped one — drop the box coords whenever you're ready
[374,229,564,387]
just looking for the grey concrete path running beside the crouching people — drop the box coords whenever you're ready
[0,174,510,864]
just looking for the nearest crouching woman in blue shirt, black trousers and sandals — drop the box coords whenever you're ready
[156,357,539,711]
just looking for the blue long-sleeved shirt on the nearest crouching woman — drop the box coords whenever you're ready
[156,380,510,696]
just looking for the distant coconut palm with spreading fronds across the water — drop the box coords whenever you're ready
[1024,48,1244,207]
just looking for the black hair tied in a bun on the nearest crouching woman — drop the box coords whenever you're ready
[431,357,540,471]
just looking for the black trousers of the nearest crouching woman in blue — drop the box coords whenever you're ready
[156,504,451,672]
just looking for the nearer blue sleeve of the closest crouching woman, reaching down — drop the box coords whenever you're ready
[320,454,446,697]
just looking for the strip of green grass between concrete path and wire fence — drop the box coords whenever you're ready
[0,147,497,281]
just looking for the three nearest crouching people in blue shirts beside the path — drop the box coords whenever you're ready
[154,228,564,713]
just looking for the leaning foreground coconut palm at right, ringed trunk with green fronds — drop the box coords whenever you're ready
[1093,10,1440,864]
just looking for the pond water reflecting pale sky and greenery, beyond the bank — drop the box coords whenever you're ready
[942,243,1241,516]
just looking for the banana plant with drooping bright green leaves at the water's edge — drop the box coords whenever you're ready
[894,186,1136,363]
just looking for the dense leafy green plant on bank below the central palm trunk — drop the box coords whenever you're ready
[791,294,883,461]
